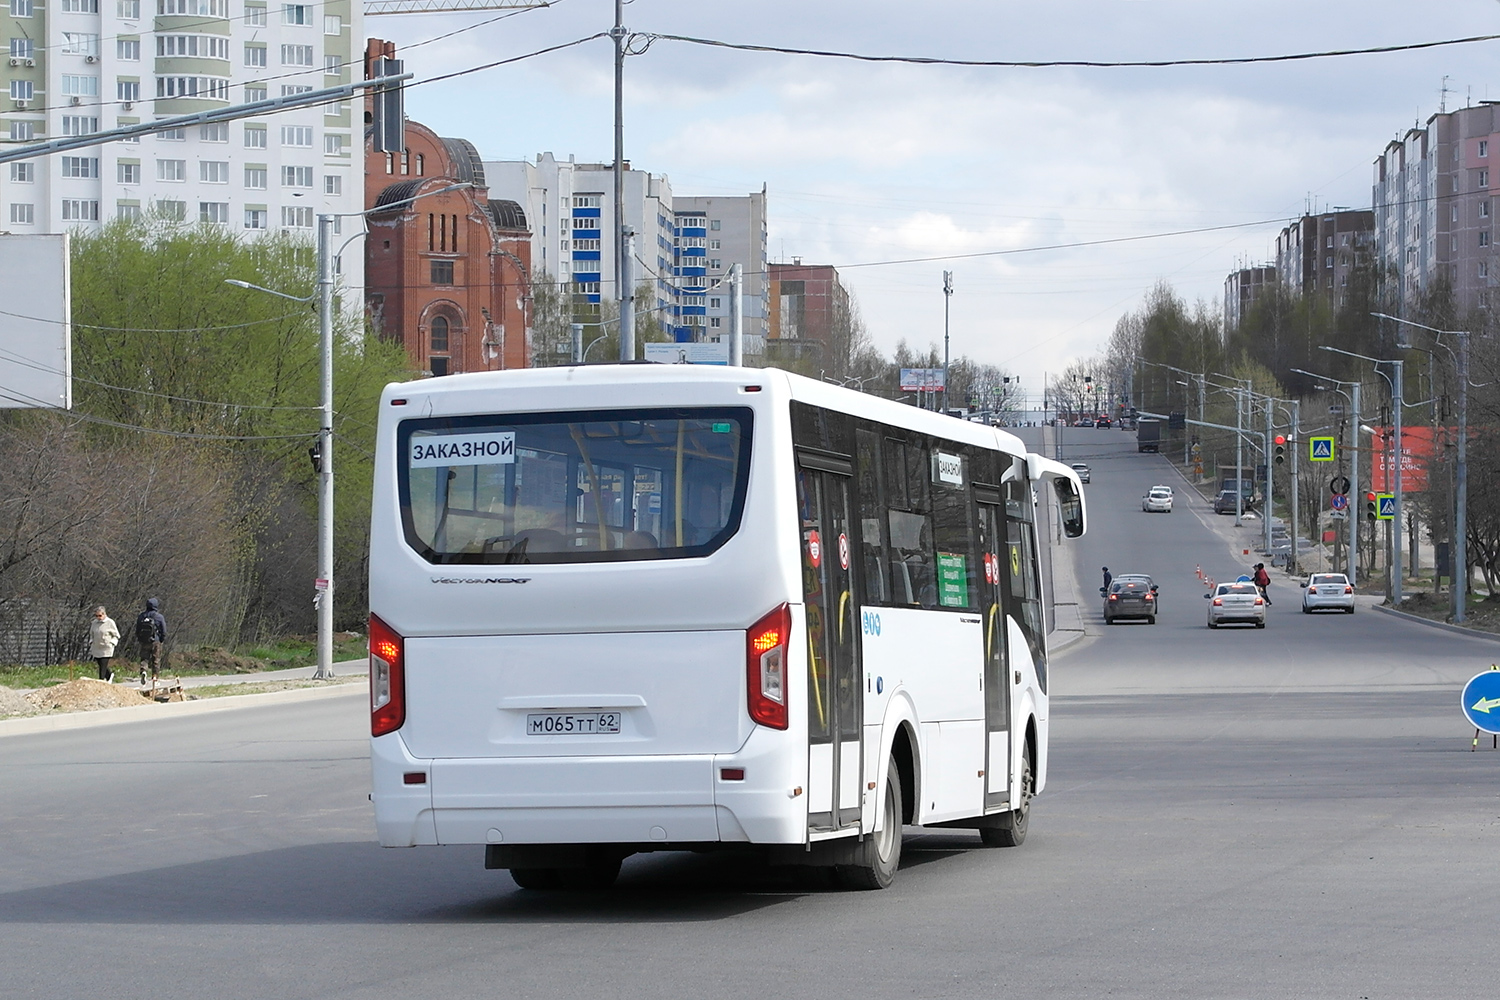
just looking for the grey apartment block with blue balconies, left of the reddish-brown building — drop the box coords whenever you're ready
[672,187,771,355]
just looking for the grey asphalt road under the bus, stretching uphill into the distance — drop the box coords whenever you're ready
[0,429,1500,1000]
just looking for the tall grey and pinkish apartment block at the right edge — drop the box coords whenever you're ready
[1373,100,1500,312]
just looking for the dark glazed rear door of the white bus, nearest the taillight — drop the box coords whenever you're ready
[797,462,864,832]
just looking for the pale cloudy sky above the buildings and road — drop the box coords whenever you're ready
[378,0,1500,394]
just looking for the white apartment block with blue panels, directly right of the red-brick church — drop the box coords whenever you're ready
[485,153,678,333]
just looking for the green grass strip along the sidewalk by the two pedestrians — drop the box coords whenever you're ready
[0,633,368,688]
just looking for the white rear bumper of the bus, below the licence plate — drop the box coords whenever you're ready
[372,732,807,849]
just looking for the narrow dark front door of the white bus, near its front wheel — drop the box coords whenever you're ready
[978,495,1011,811]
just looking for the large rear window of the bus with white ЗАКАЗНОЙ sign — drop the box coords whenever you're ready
[398,408,752,564]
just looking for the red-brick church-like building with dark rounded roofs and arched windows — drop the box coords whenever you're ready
[365,55,531,375]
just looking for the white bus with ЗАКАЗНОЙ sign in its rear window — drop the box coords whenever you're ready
[371,364,1085,889]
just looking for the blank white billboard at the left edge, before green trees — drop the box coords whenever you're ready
[0,234,74,409]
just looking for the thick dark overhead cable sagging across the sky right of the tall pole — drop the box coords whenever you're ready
[632,31,1500,69]
